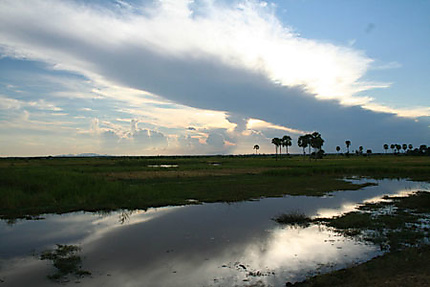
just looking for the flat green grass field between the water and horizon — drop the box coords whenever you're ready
[0,156,430,218]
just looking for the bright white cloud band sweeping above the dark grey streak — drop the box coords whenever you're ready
[0,0,372,100]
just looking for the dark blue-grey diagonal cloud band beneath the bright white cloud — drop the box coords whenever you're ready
[92,44,430,151]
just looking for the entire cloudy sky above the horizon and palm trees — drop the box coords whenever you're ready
[0,0,430,157]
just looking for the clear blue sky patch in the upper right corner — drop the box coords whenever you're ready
[277,0,430,108]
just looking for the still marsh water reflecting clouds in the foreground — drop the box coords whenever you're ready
[0,179,430,287]
